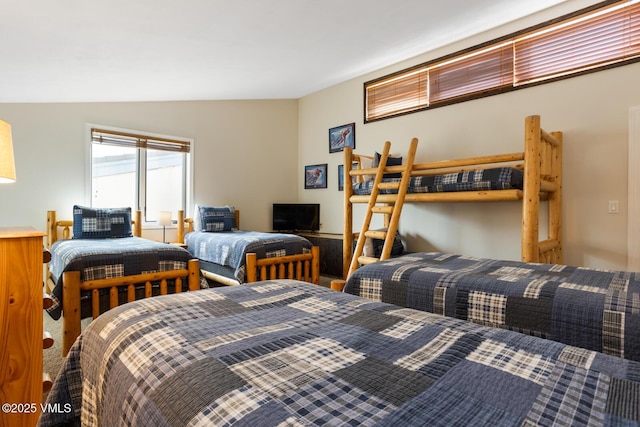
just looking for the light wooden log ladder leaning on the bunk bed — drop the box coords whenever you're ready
[347,138,418,277]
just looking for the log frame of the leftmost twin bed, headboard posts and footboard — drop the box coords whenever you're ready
[46,211,200,356]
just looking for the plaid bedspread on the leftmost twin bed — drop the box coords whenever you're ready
[47,237,193,319]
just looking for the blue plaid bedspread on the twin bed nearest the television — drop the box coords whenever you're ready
[185,230,312,283]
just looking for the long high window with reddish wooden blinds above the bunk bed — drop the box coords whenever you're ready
[364,0,640,123]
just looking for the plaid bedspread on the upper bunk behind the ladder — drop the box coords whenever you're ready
[353,168,524,195]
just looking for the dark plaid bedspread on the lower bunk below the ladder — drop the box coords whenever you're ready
[344,253,640,361]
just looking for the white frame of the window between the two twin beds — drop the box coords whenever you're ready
[85,123,195,227]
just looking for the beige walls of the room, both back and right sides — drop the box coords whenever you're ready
[0,0,640,269]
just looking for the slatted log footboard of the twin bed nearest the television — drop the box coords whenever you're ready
[247,246,320,284]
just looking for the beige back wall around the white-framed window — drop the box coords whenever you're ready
[0,100,301,238]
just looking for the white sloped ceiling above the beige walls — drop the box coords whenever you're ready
[0,0,565,103]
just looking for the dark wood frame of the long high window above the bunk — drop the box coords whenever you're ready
[363,0,640,124]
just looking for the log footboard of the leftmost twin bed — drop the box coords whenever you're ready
[62,259,200,357]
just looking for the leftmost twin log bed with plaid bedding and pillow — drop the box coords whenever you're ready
[45,206,200,356]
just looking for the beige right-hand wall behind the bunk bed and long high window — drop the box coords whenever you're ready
[299,1,640,269]
